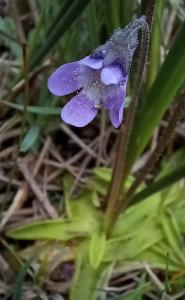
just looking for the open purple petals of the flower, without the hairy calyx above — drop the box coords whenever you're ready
[48,56,128,128]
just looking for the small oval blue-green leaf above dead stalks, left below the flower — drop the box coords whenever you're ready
[20,125,39,152]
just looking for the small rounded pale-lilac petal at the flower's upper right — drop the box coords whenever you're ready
[100,64,124,85]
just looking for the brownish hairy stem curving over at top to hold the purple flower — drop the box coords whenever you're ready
[104,17,149,235]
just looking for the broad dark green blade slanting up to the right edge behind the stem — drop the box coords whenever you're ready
[126,22,185,173]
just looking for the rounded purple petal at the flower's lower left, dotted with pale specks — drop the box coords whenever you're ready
[61,92,98,127]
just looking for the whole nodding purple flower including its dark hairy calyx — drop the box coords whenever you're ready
[48,16,145,128]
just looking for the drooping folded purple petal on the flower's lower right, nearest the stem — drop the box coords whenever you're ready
[103,84,126,128]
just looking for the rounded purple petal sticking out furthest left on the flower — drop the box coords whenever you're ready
[48,62,83,96]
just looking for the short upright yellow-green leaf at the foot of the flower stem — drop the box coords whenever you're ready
[89,232,106,270]
